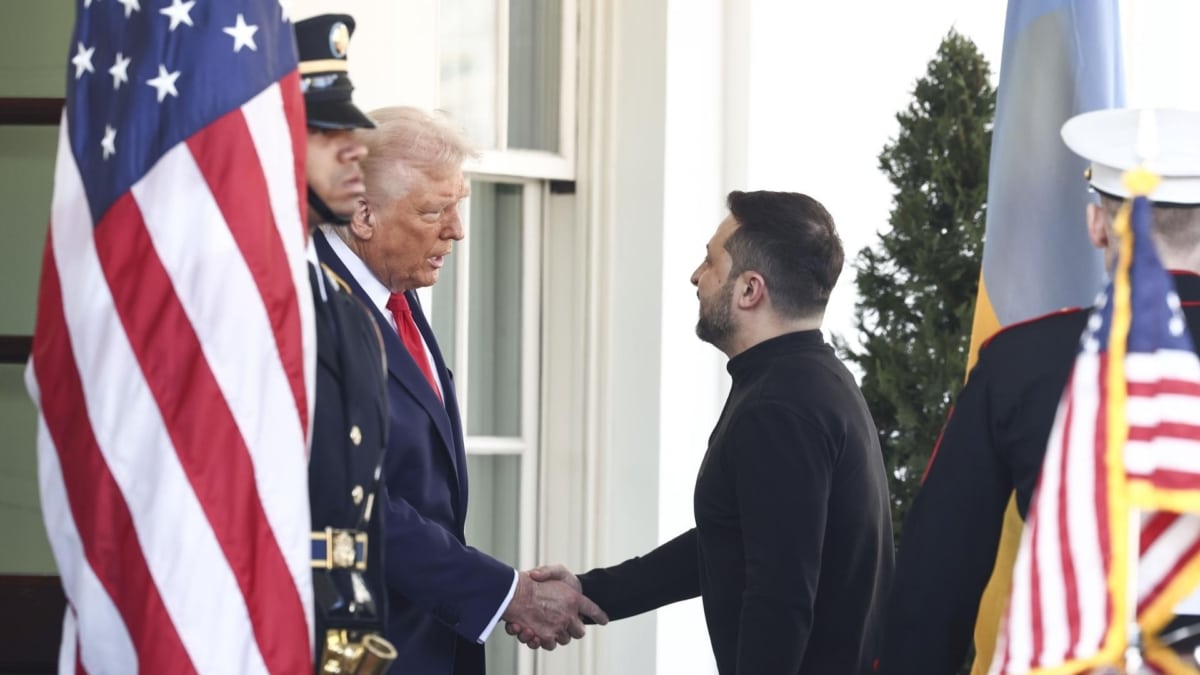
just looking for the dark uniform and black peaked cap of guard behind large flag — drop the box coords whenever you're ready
[295,14,396,675]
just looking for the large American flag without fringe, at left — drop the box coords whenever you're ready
[26,0,316,674]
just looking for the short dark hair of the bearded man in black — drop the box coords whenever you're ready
[725,190,845,318]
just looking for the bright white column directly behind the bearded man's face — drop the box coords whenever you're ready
[656,0,746,675]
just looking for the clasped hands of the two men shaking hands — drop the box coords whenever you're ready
[502,565,608,651]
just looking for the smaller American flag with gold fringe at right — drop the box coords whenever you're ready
[991,178,1200,675]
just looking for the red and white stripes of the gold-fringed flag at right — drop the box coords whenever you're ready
[991,350,1200,674]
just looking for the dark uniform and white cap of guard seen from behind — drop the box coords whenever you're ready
[878,110,1200,675]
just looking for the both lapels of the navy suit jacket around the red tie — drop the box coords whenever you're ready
[313,234,466,475]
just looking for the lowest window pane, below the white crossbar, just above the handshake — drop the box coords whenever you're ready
[467,454,523,675]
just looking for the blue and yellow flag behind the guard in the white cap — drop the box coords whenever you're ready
[967,0,1124,675]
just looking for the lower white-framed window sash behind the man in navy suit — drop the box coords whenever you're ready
[430,180,535,675]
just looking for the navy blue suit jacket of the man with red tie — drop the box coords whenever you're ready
[313,234,512,675]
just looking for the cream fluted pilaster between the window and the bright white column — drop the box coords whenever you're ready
[566,0,667,675]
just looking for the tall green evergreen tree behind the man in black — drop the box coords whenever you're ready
[838,29,996,542]
